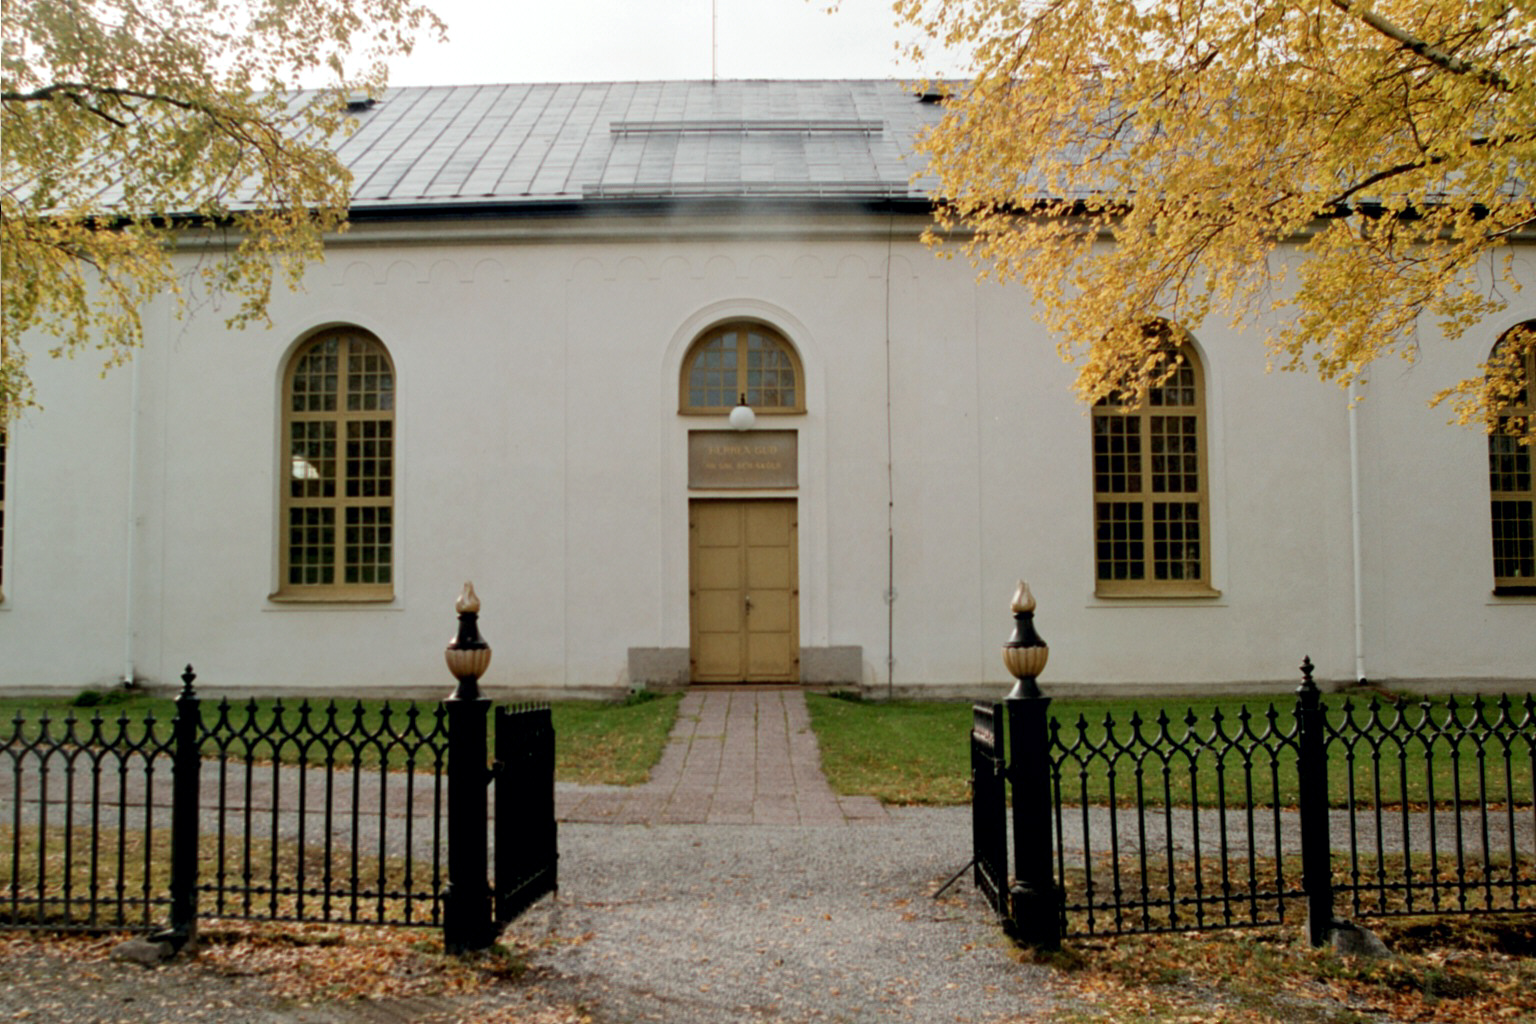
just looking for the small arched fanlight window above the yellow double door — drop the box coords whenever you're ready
[677,321,805,415]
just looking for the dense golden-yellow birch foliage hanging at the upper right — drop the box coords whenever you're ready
[895,0,1536,441]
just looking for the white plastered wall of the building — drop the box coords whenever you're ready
[0,218,1536,694]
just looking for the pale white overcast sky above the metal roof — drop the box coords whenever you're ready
[377,0,963,86]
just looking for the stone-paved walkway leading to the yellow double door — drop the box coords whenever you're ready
[554,686,888,824]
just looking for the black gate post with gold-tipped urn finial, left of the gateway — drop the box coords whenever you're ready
[442,583,496,953]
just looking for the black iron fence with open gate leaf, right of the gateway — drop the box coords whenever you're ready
[972,662,1536,944]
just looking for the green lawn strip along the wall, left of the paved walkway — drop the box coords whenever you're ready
[0,691,680,786]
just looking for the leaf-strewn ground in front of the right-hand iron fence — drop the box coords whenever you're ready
[1020,915,1536,1024]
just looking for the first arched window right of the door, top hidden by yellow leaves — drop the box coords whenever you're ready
[1094,327,1215,597]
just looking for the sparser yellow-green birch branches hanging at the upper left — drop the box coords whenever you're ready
[0,0,442,427]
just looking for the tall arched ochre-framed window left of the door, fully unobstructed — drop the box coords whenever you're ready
[276,327,395,600]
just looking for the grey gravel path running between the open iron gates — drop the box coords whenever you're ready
[511,808,1048,1024]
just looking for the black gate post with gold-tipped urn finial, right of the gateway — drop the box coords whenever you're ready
[1003,580,1061,949]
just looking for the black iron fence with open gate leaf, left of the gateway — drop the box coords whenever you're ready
[0,668,558,947]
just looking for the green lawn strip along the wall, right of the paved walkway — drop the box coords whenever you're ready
[808,694,1533,808]
